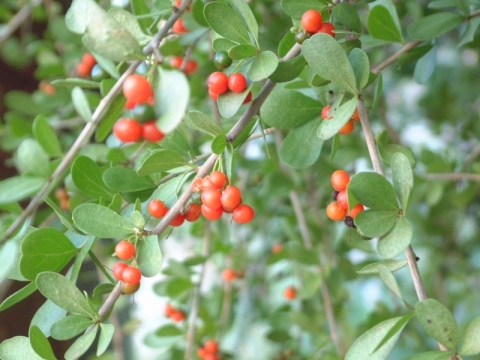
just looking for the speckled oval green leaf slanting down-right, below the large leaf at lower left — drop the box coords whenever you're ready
[35,272,95,317]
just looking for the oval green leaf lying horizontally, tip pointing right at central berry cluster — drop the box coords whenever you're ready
[72,203,134,238]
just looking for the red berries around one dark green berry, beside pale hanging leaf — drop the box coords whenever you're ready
[113,74,165,143]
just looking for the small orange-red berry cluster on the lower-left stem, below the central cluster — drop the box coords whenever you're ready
[112,240,142,294]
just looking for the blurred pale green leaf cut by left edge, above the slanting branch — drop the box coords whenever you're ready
[0,176,45,204]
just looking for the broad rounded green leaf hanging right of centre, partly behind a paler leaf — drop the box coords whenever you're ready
[279,120,323,169]
